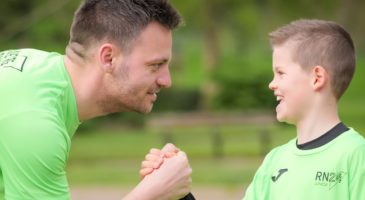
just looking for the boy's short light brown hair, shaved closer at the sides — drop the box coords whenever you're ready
[269,19,356,99]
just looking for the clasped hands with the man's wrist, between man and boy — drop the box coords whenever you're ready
[124,144,192,200]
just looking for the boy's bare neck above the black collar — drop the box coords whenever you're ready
[296,101,341,144]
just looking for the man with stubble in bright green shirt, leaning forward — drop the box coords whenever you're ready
[0,0,191,200]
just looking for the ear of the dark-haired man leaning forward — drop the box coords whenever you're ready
[99,43,117,73]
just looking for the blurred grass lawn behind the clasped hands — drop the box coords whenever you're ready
[67,125,293,187]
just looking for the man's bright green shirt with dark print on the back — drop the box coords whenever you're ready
[0,49,79,200]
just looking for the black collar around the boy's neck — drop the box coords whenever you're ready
[297,122,349,150]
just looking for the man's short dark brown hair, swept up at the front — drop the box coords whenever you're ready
[70,0,182,51]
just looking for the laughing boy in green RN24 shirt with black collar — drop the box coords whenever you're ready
[243,20,365,200]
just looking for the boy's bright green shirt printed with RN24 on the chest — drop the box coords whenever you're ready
[243,129,365,200]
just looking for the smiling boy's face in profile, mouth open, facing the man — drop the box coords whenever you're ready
[269,42,312,124]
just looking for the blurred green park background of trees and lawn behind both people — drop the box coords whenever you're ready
[0,0,365,197]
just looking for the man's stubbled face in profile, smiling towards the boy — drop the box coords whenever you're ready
[100,22,172,113]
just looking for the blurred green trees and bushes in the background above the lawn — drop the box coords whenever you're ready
[0,0,365,116]
